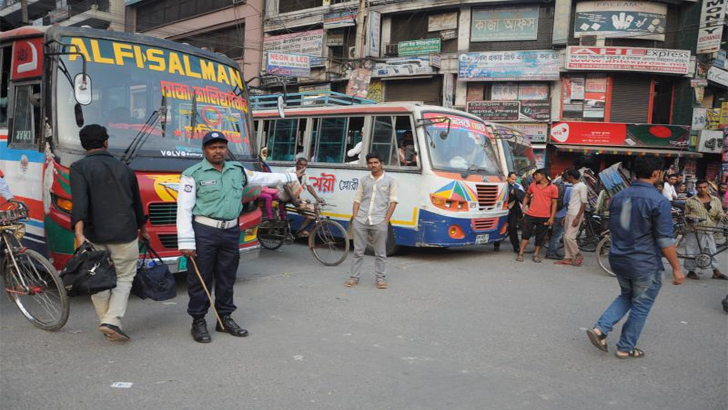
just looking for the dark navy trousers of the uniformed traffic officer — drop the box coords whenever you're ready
[187,222,240,319]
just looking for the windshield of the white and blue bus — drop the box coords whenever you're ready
[424,113,501,175]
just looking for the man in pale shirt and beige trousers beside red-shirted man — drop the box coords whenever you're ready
[556,169,587,266]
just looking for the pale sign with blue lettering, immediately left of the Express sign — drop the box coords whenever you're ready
[458,50,560,81]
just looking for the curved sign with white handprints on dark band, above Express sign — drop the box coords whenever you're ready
[574,1,667,41]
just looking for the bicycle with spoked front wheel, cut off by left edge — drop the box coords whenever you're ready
[0,202,69,331]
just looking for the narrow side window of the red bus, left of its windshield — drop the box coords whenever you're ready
[8,84,40,148]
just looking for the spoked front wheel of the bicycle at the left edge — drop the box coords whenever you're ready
[2,249,69,330]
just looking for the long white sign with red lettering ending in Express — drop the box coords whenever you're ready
[566,46,690,75]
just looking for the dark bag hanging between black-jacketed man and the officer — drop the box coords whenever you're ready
[131,243,177,302]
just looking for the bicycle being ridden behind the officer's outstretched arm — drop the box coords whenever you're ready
[258,202,349,266]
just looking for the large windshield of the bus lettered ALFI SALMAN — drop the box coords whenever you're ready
[56,37,252,158]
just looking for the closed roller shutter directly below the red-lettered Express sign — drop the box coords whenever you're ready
[610,74,650,123]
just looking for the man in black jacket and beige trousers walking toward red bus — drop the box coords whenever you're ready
[70,124,149,341]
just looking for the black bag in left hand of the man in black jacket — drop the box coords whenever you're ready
[60,242,116,296]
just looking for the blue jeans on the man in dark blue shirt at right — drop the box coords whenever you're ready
[595,271,662,352]
